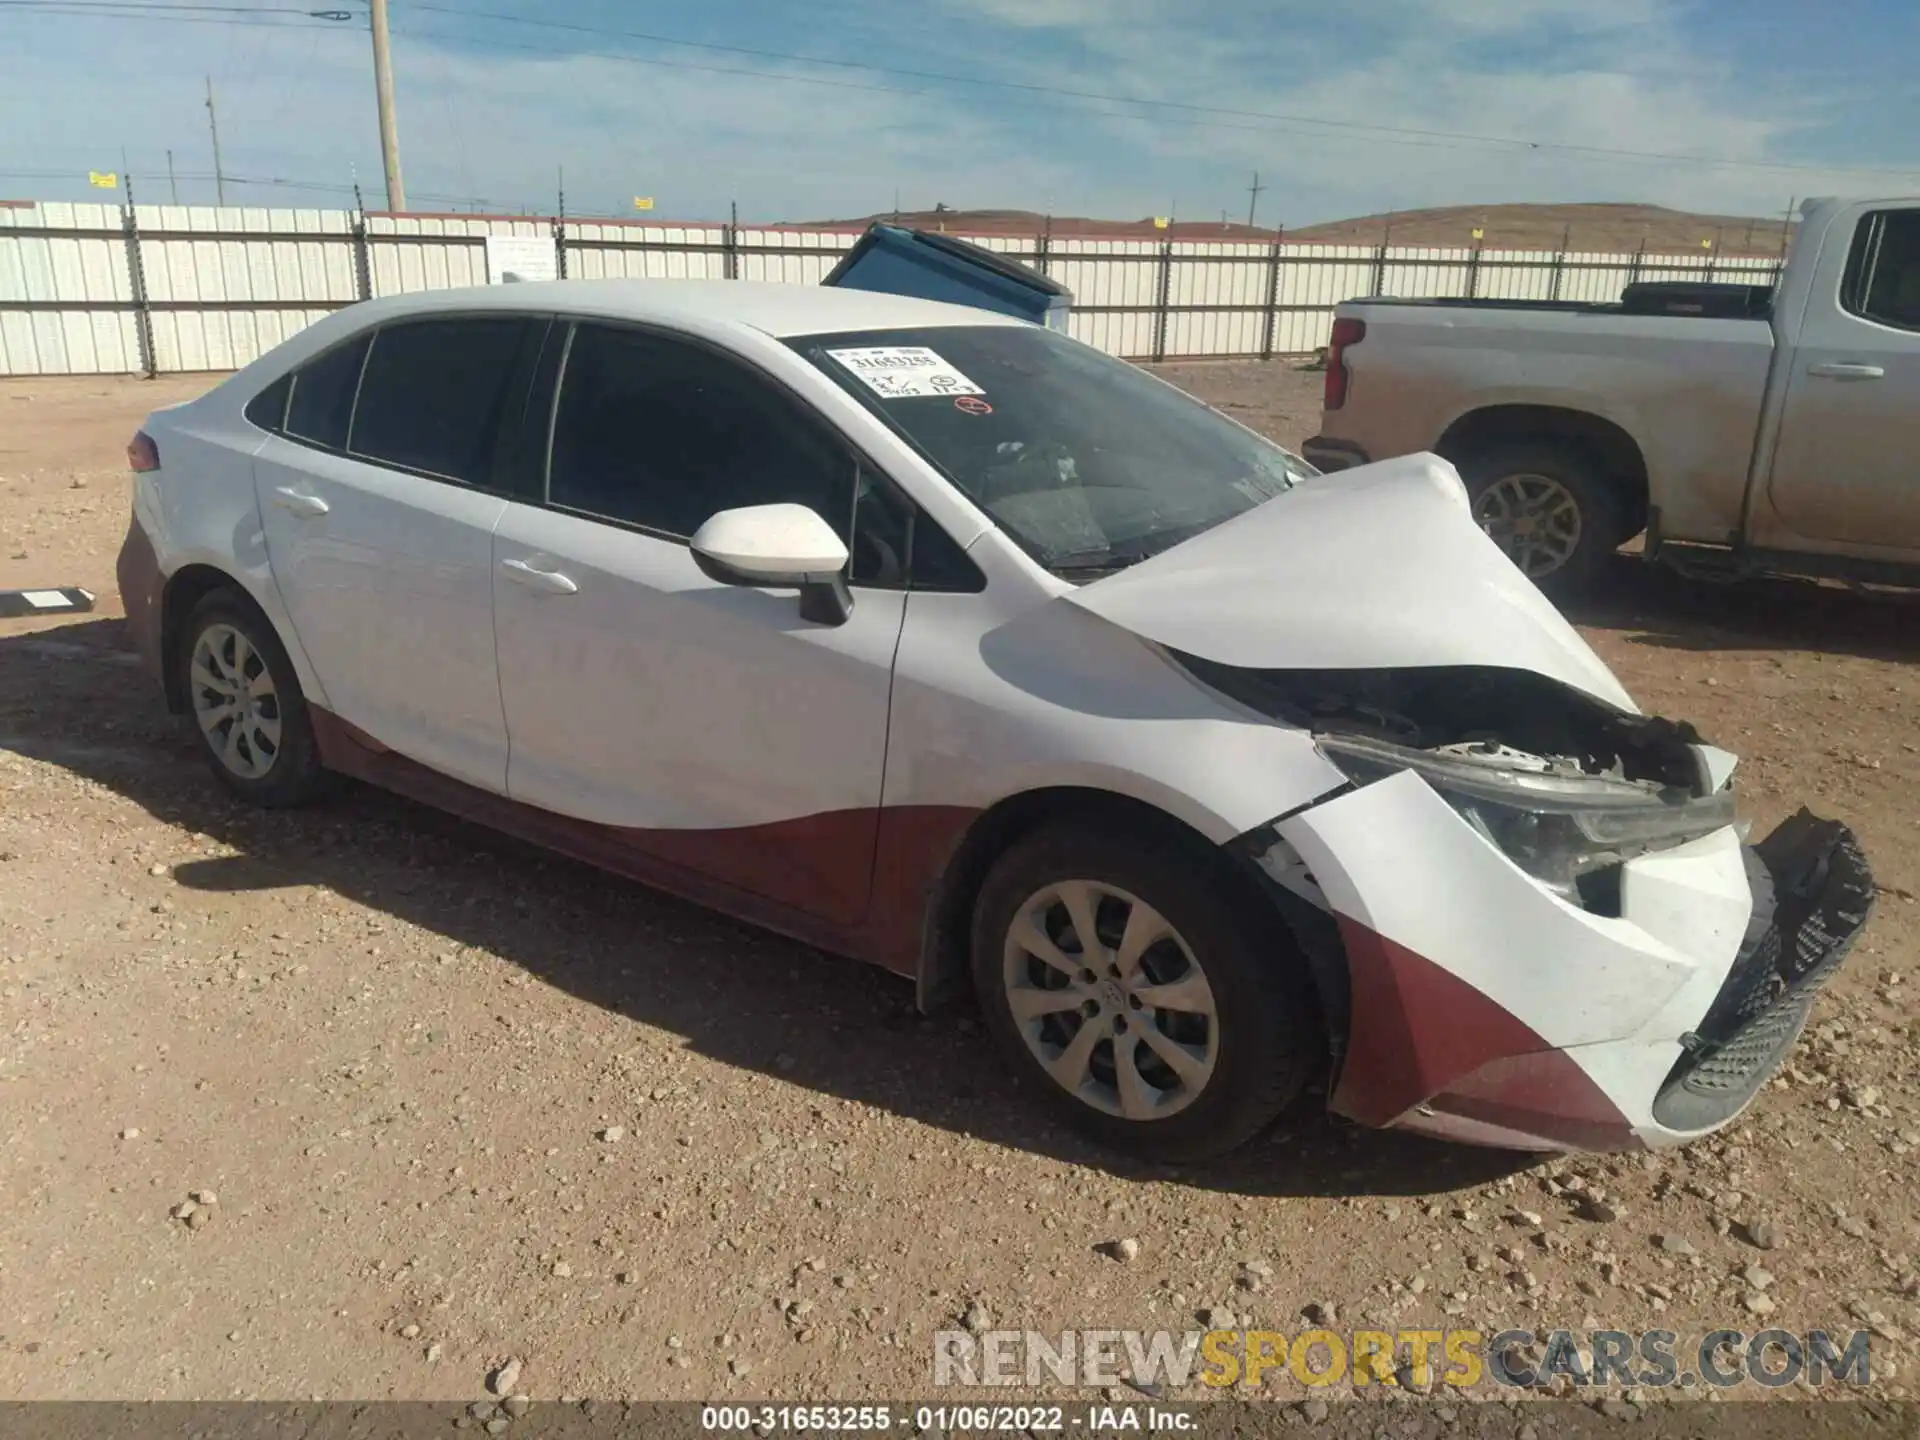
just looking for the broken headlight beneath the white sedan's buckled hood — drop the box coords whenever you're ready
[1315,735,1734,904]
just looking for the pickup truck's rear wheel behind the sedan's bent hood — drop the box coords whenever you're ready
[1459,440,1630,597]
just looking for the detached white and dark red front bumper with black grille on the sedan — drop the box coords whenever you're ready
[1261,774,1874,1150]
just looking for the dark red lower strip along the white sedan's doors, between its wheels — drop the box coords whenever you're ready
[309,707,977,975]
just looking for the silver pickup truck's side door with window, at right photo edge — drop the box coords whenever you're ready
[1757,207,1920,555]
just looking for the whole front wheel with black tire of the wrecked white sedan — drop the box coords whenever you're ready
[972,822,1323,1164]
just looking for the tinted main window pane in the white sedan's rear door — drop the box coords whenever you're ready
[349,315,532,486]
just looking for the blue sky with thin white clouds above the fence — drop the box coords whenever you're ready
[0,0,1920,225]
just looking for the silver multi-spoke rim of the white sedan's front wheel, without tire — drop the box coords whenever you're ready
[1000,879,1219,1121]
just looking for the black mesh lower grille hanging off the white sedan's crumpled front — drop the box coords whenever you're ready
[1653,810,1874,1131]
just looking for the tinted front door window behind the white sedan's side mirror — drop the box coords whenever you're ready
[547,324,856,540]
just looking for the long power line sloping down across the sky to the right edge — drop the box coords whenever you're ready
[409,2,1920,175]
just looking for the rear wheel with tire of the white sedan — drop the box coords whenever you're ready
[173,589,334,808]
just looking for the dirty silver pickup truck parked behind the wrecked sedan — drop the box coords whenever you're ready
[1304,200,1920,595]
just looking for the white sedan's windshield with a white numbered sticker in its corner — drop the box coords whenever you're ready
[789,324,1315,580]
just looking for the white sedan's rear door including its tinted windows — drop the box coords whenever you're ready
[253,315,547,793]
